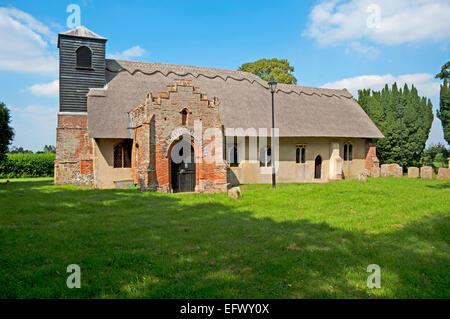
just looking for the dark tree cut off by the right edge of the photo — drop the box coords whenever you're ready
[436,61,450,144]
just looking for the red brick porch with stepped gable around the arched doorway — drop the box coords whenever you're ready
[129,80,227,193]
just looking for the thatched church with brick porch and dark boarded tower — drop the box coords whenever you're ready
[55,27,383,193]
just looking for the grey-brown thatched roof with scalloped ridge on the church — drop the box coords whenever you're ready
[88,60,383,138]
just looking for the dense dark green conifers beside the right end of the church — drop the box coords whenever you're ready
[358,83,433,166]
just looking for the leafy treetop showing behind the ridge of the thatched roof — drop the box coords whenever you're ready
[238,58,297,84]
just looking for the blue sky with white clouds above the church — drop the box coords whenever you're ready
[0,0,450,151]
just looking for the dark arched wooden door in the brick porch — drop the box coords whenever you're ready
[170,140,196,193]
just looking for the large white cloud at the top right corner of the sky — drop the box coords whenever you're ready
[303,0,450,45]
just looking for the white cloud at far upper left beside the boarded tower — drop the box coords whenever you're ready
[0,7,58,74]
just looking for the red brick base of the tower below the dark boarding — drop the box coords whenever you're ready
[55,114,94,185]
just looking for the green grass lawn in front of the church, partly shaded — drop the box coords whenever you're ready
[0,177,450,298]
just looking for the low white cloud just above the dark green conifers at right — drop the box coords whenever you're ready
[322,73,440,99]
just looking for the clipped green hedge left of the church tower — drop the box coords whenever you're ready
[0,153,55,178]
